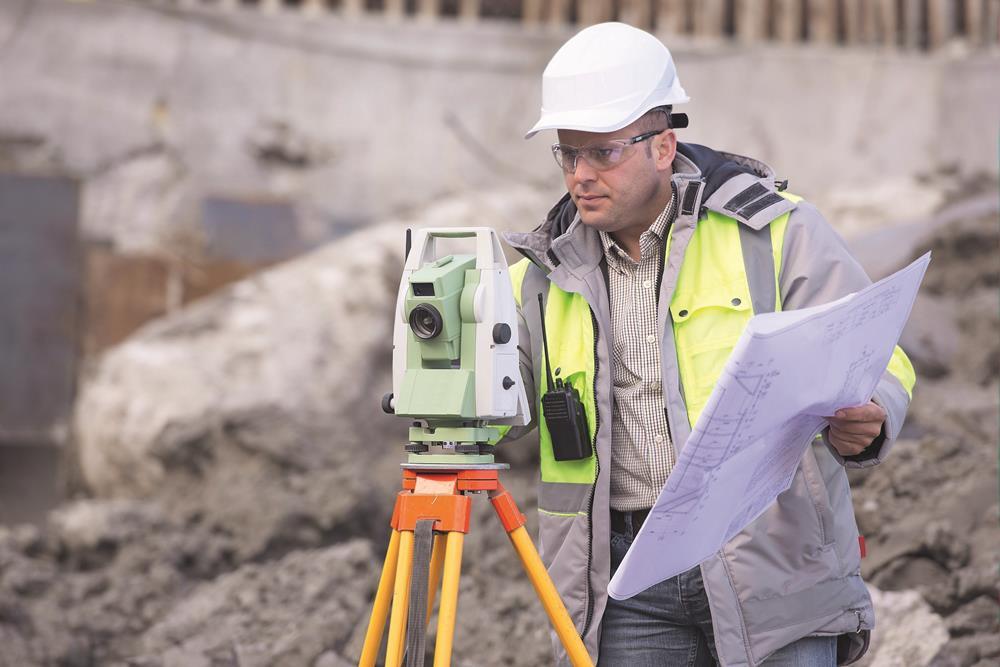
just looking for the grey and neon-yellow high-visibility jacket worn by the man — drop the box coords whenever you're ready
[506,144,914,665]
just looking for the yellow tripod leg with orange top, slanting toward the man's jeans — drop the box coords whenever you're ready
[490,482,594,667]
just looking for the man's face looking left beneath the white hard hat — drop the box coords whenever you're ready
[559,117,677,233]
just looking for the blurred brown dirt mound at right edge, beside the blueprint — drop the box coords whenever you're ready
[850,205,1000,667]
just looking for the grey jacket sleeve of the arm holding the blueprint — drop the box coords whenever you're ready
[779,202,910,468]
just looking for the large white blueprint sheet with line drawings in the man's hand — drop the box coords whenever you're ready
[608,253,930,600]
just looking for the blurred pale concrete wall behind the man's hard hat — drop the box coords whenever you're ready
[0,0,1000,250]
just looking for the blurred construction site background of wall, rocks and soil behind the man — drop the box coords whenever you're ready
[0,0,1000,667]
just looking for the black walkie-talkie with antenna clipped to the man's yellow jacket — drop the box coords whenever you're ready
[538,294,593,461]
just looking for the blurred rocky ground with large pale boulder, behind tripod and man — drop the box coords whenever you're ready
[0,191,1000,667]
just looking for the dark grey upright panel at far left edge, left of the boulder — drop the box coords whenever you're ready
[0,174,83,441]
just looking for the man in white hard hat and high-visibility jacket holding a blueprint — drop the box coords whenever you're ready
[507,23,914,666]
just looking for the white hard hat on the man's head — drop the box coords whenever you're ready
[524,23,690,139]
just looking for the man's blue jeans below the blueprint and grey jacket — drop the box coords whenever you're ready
[598,526,837,667]
